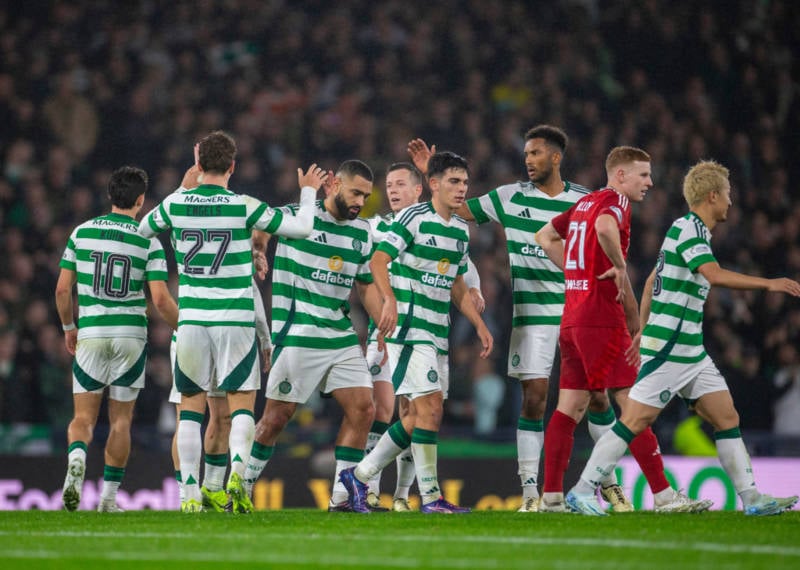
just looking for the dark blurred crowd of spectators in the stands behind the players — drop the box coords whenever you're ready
[0,0,800,453]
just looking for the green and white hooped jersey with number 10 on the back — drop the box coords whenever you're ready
[59,213,169,340]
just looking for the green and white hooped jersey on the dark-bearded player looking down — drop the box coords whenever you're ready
[272,201,372,349]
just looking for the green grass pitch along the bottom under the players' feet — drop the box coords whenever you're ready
[0,509,800,570]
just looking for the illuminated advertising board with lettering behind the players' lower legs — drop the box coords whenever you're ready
[0,454,800,510]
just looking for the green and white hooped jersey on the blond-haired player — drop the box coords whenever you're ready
[640,212,716,364]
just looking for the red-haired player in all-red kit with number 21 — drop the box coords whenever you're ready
[536,146,708,512]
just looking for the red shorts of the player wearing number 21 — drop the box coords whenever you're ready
[558,327,638,391]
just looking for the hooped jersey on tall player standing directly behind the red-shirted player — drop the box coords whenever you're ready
[467,182,590,327]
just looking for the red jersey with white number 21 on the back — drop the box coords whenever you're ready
[552,188,631,328]
